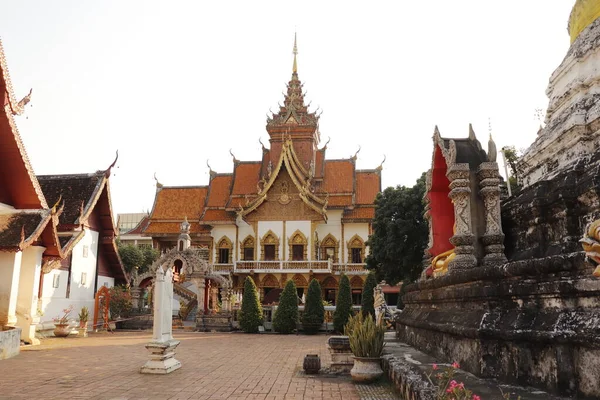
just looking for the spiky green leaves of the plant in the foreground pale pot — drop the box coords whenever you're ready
[345,313,386,358]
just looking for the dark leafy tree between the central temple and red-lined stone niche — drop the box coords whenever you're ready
[366,173,429,284]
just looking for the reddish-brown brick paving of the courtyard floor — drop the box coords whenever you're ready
[0,332,360,400]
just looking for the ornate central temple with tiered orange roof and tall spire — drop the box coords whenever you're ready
[143,38,382,304]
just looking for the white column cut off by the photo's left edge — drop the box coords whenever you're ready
[0,251,23,326]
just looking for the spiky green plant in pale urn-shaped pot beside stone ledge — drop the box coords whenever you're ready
[345,313,386,383]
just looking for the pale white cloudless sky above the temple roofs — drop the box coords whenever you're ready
[0,0,574,216]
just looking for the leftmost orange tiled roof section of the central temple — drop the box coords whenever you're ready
[150,186,208,221]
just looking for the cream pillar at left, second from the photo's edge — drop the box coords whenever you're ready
[17,246,46,344]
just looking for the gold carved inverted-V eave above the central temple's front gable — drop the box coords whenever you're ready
[238,139,327,221]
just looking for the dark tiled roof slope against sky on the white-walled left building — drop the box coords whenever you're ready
[38,172,104,225]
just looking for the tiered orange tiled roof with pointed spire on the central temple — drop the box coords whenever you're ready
[145,36,381,236]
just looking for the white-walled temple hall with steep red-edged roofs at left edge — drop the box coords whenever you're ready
[0,39,127,358]
